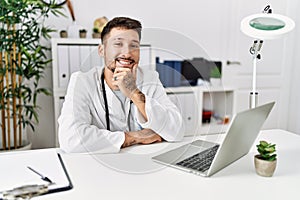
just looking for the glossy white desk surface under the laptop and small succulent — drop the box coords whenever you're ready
[0,130,300,200]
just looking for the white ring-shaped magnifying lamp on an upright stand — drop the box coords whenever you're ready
[240,5,295,108]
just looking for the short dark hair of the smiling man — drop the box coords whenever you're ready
[101,17,142,43]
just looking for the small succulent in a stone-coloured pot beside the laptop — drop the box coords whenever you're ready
[254,140,277,177]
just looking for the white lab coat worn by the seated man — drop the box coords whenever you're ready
[58,67,183,153]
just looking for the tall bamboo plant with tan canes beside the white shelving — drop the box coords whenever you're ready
[0,0,62,150]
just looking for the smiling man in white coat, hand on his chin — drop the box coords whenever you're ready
[58,17,183,153]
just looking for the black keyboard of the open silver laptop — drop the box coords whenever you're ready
[176,145,219,172]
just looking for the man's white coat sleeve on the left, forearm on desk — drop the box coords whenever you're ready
[58,72,125,153]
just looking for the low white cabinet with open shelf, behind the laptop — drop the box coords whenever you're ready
[166,86,235,136]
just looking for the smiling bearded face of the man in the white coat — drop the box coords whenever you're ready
[100,28,140,72]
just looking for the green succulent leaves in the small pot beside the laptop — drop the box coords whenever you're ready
[256,140,277,161]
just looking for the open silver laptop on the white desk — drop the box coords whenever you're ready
[152,102,275,176]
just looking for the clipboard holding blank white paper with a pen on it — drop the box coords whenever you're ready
[0,149,73,199]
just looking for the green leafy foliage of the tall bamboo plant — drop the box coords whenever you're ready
[0,0,63,133]
